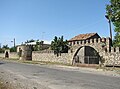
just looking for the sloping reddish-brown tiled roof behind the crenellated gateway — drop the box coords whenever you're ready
[69,33,97,41]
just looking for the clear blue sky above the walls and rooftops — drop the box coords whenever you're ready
[0,0,114,46]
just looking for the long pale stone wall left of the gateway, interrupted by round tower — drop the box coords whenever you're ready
[0,51,73,64]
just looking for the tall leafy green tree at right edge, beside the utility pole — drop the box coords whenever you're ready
[106,0,120,47]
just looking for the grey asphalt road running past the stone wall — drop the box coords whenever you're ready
[0,60,120,89]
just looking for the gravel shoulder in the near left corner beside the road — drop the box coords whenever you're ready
[0,70,50,89]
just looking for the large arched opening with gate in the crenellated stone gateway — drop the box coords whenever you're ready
[73,46,100,64]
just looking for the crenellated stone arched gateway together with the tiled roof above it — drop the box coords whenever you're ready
[68,33,111,64]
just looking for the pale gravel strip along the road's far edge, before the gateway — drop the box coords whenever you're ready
[51,65,120,77]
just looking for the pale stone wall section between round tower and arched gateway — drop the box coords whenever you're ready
[32,51,73,64]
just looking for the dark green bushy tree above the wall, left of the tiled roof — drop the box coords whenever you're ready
[51,36,68,56]
